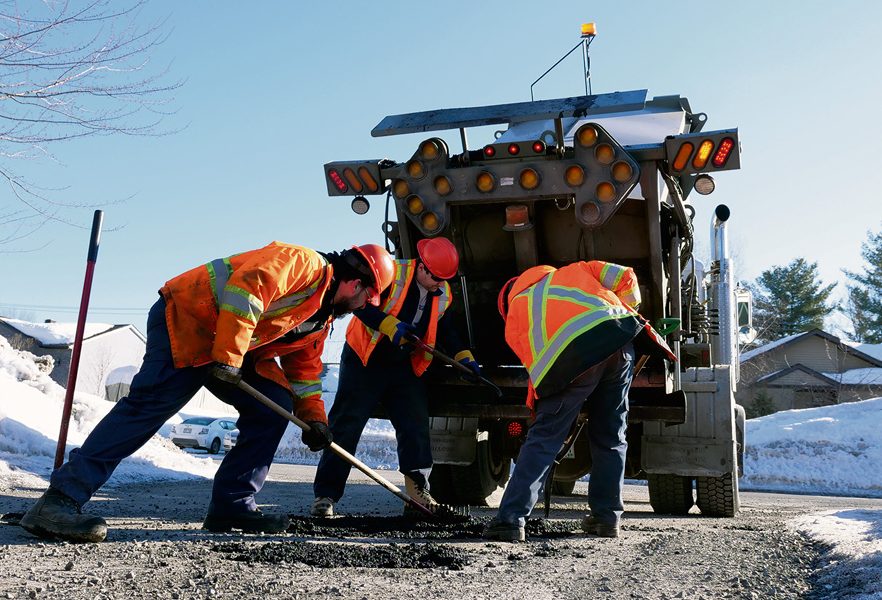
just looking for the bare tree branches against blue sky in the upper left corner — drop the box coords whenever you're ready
[0,0,183,245]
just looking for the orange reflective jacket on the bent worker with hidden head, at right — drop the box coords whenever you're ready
[505,260,674,408]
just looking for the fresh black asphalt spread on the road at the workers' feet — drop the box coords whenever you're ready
[212,516,578,570]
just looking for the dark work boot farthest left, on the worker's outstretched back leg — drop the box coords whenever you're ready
[20,488,107,542]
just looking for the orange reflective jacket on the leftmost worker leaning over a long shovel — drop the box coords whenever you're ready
[160,242,333,422]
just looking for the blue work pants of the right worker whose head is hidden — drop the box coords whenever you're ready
[497,342,634,527]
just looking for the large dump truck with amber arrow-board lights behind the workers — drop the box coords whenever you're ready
[324,81,744,516]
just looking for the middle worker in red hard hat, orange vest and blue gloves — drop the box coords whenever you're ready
[310,237,480,517]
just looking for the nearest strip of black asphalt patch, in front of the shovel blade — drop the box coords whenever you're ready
[212,542,472,571]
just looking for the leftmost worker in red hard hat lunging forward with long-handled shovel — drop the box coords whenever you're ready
[21,242,394,542]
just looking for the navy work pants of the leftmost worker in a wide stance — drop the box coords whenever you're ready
[49,298,292,515]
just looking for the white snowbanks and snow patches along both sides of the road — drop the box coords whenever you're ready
[0,328,882,598]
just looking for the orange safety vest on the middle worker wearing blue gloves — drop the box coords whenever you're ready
[346,260,451,377]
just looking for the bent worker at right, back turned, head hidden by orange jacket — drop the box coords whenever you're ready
[484,260,675,541]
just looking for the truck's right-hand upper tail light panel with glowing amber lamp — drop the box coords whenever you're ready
[665,129,741,175]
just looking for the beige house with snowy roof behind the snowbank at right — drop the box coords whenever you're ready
[735,329,882,415]
